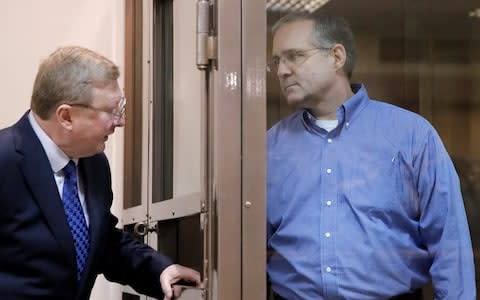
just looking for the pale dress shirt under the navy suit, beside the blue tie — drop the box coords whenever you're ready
[28,111,89,226]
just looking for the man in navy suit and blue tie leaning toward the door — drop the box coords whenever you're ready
[0,47,200,300]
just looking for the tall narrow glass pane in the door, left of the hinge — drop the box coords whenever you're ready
[152,0,202,203]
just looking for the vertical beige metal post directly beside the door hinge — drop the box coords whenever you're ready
[209,0,242,300]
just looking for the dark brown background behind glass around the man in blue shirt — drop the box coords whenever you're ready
[267,0,480,299]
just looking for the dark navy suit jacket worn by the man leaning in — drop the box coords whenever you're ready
[0,114,171,300]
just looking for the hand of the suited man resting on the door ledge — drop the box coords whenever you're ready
[160,264,201,299]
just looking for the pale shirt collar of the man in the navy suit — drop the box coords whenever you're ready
[28,111,78,173]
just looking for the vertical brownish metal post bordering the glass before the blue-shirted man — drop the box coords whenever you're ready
[241,0,267,300]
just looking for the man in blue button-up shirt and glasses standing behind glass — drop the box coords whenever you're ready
[267,15,476,300]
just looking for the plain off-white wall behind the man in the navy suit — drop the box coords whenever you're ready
[0,0,125,300]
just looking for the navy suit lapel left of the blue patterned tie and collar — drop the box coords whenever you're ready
[14,114,76,268]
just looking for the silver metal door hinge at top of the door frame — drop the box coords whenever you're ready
[197,0,217,70]
